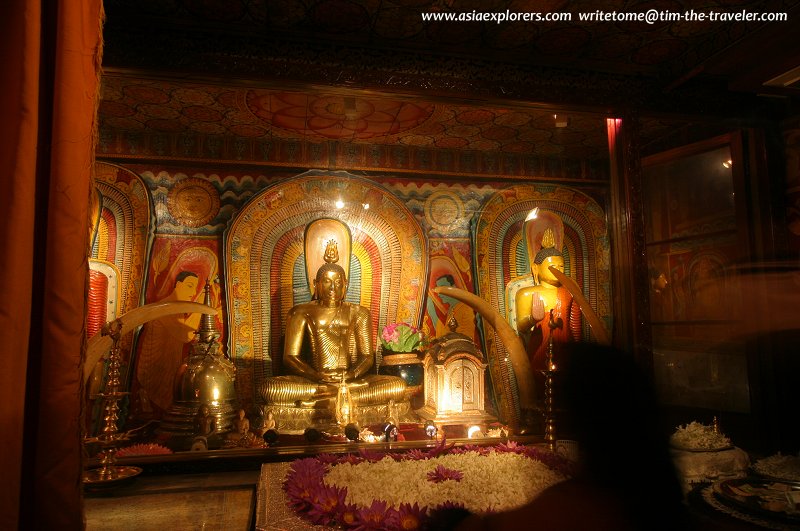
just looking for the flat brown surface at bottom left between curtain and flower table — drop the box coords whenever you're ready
[84,470,259,531]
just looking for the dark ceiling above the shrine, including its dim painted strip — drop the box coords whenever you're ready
[100,0,800,163]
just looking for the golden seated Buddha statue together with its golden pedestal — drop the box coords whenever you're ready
[259,241,417,430]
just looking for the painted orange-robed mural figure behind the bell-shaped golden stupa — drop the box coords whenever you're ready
[136,271,202,414]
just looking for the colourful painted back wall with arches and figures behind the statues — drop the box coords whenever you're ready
[100,164,611,428]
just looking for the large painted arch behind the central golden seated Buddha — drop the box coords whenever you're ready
[224,172,428,406]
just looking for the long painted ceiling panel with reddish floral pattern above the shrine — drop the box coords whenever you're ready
[99,75,607,159]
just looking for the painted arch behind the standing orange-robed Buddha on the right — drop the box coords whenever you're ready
[473,184,612,426]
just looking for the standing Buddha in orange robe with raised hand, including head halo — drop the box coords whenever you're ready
[514,210,581,375]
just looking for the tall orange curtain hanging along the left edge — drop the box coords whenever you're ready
[0,0,103,529]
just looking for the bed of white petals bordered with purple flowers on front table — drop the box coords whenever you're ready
[283,440,574,529]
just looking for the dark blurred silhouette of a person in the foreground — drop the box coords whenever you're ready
[439,343,693,531]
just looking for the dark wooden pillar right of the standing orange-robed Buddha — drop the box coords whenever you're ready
[607,113,652,365]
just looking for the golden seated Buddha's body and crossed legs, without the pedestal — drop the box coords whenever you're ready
[261,241,407,406]
